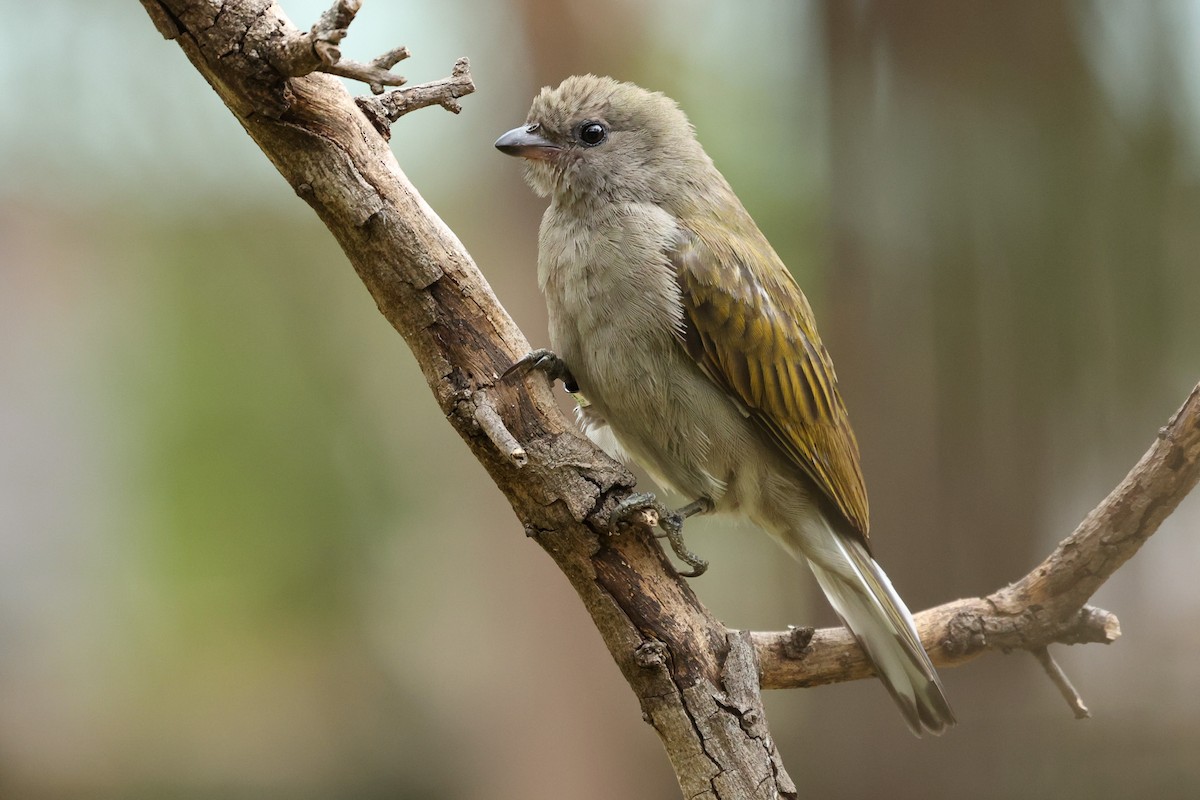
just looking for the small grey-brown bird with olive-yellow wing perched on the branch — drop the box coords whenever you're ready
[496,76,955,735]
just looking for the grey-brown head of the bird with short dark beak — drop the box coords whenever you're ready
[496,74,712,205]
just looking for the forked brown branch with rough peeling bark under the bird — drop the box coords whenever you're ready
[142,0,1200,798]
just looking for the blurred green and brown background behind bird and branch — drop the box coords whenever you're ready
[0,0,1200,800]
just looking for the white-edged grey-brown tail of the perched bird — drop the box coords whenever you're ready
[806,534,956,736]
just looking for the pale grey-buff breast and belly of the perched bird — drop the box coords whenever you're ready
[539,199,752,501]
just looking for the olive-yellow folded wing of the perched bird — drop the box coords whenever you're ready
[667,220,869,545]
